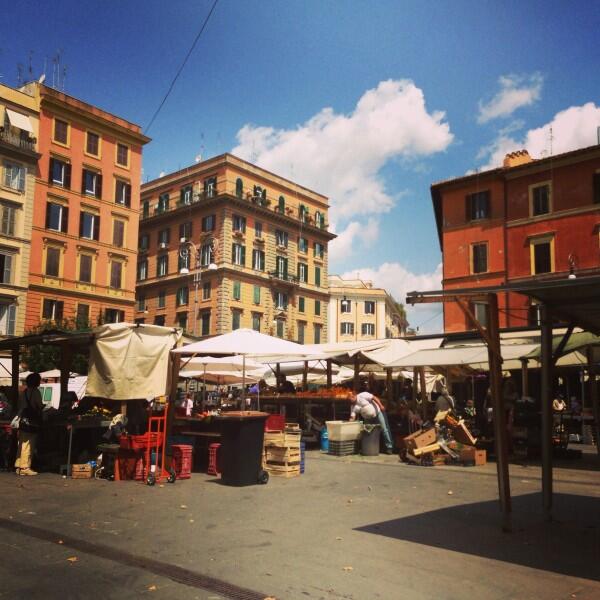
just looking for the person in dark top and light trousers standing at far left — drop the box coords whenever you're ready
[15,373,44,475]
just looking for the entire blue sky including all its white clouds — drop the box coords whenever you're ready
[0,0,600,331]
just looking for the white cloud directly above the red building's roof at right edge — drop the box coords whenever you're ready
[479,102,600,170]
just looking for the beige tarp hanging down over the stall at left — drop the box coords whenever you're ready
[87,323,181,400]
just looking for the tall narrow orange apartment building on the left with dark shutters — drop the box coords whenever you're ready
[22,83,150,329]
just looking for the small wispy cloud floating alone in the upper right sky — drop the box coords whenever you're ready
[477,73,544,123]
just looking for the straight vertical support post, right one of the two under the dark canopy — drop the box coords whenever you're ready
[540,304,554,521]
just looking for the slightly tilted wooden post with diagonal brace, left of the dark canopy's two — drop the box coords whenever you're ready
[487,294,512,531]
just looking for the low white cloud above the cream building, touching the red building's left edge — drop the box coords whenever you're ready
[341,262,443,334]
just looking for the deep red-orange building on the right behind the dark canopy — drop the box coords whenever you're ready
[431,146,600,332]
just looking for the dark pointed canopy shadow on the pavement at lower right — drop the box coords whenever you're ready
[356,494,600,581]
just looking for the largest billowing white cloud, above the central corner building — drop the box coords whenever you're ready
[232,79,453,224]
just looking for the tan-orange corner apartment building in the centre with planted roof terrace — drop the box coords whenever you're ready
[136,154,335,343]
